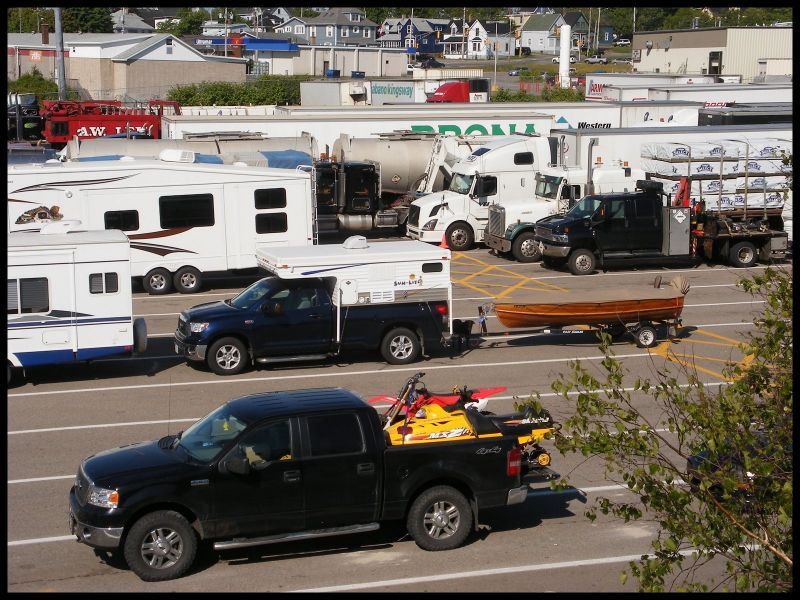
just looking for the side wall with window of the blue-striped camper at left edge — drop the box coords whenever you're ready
[8,250,78,367]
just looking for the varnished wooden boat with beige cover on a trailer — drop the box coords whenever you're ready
[494,276,689,328]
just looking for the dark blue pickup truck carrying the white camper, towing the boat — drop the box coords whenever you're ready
[175,276,449,375]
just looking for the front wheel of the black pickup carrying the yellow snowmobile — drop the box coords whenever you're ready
[125,510,197,581]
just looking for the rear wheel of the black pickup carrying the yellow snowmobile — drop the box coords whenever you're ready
[406,485,472,552]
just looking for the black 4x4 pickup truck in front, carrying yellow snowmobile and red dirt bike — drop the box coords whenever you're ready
[69,388,537,581]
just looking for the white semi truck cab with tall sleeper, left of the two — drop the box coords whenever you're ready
[407,134,550,251]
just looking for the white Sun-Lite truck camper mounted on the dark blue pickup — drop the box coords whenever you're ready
[256,236,453,341]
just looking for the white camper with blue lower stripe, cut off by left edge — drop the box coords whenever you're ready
[7,222,147,383]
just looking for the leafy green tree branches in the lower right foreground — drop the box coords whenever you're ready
[530,267,793,591]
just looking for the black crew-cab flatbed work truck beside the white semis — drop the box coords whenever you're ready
[534,178,788,275]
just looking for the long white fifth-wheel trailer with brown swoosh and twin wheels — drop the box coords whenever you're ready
[7,151,316,294]
